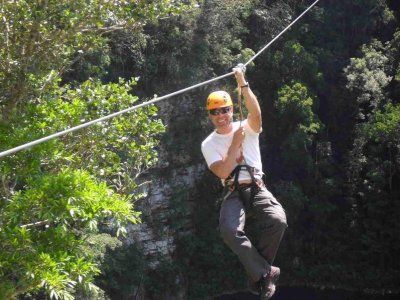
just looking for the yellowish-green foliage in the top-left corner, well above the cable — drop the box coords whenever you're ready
[0,0,188,112]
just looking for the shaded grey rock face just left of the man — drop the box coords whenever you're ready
[126,89,211,267]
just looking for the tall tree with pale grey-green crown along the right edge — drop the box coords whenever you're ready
[345,29,400,289]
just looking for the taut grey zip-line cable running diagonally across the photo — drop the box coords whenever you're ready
[0,0,319,157]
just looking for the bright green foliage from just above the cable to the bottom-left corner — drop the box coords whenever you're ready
[0,80,164,298]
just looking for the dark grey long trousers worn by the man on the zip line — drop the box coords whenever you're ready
[219,187,287,282]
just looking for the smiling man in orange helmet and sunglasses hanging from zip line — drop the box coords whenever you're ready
[201,67,287,299]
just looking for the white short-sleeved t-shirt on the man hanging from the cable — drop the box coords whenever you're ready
[201,119,262,181]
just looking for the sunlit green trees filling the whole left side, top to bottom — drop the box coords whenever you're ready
[0,0,187,299]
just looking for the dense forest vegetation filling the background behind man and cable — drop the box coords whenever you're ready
[0,0,400,299]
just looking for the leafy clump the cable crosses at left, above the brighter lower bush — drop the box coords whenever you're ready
[0,80,164,193]
